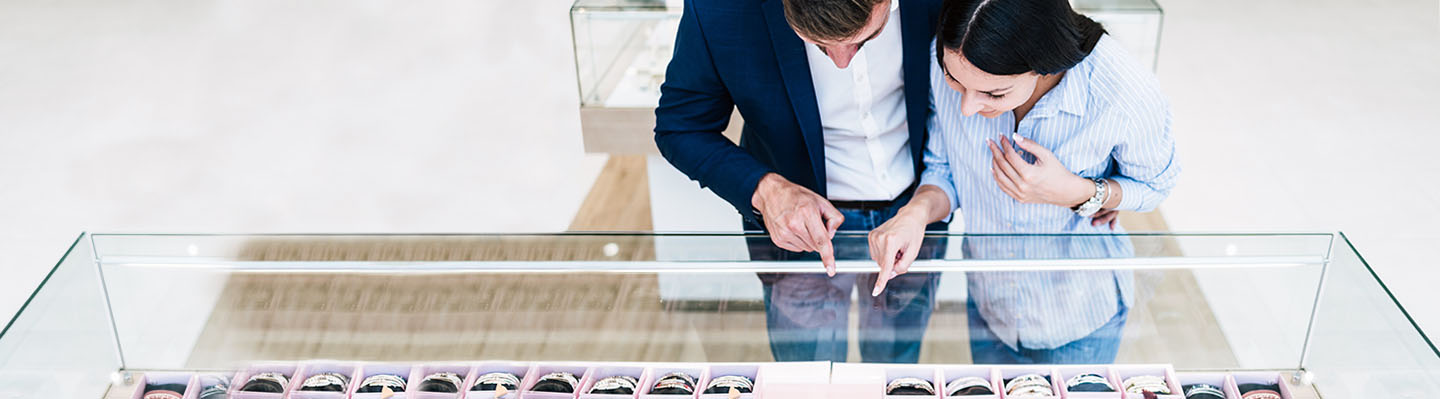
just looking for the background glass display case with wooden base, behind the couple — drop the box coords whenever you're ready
[570,0,1164,153]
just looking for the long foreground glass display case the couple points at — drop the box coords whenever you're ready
[0,233,1440,399]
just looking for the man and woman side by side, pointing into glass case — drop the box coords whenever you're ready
[655,0,1179,363]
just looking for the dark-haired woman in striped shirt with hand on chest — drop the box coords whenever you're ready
[870,0,1179,363]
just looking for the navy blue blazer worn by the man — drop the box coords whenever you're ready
[655,0,940,222]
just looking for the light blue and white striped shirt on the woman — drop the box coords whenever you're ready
[920,36,1179,349]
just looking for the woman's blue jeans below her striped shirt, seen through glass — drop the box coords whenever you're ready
[965,300,1130,364]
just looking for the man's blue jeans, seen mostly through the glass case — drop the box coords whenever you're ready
[744,199,946,363]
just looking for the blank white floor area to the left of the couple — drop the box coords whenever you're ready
[0,0,603,323]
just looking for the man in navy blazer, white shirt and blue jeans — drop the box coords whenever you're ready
[655,0,945,363]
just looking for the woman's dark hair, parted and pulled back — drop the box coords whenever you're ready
[935,0,1104,75]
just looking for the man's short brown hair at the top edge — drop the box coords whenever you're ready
[783,0,886,42]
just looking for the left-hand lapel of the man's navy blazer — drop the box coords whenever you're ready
[760,0,825,196]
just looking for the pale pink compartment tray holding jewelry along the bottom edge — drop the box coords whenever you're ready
[131,360,1297,399]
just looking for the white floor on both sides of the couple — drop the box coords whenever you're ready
[0,0,1440,354]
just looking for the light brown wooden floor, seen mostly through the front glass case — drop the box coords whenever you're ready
[104,156,1296,394]
